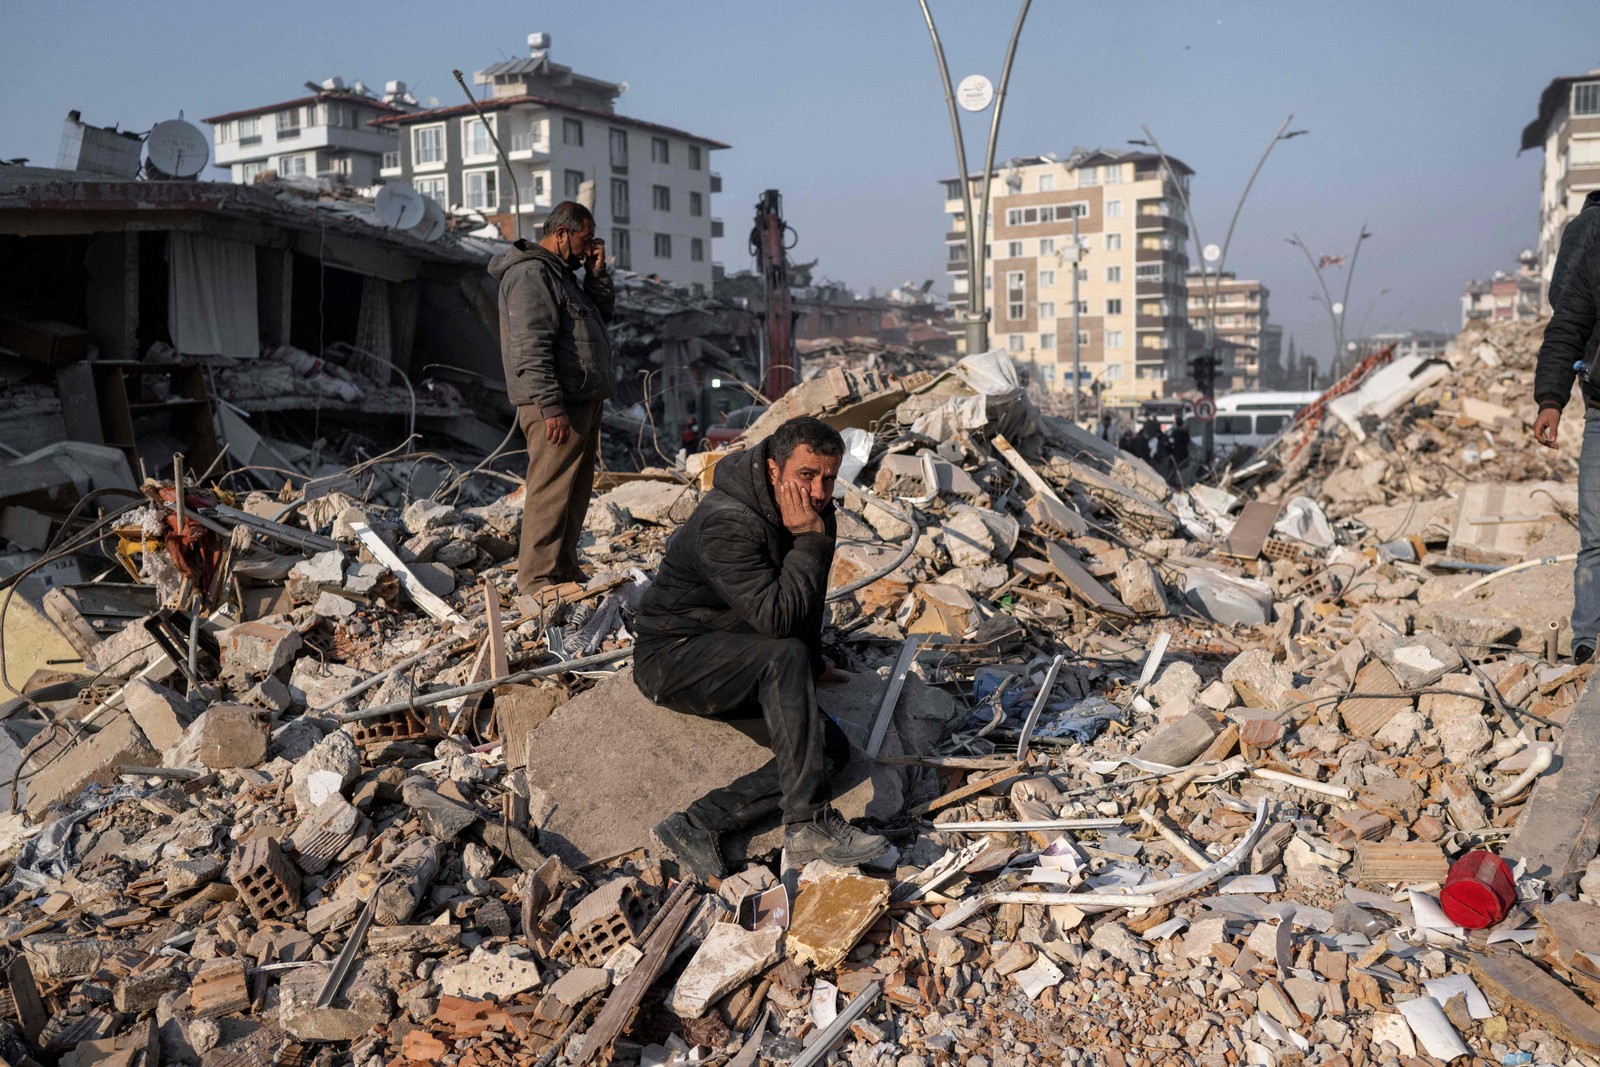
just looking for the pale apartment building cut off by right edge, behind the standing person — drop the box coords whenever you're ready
[1522,70,1600,303]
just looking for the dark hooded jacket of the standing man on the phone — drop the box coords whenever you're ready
[490,240,616,418]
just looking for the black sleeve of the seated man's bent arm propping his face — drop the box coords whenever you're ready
[699,512,834,648]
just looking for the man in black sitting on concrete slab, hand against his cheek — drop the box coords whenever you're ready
[634,416,888,878]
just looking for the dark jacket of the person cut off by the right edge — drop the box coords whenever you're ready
[1533,190,1600,411]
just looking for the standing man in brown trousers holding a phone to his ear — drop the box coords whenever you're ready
[490,200,616,595]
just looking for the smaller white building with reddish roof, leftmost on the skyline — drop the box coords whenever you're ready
[203,78,416,186]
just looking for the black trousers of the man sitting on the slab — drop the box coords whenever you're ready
[634,633,850,833]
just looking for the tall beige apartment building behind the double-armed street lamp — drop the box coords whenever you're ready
[944,149,1194,406]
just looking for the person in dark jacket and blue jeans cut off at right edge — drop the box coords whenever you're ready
[1533,192,1600,664]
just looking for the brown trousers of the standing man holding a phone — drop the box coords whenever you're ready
[517,402,602,593]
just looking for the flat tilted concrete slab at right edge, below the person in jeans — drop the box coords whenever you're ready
[1502,683,1600,893]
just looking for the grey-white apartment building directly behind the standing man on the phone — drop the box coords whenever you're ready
[378,34,728,293]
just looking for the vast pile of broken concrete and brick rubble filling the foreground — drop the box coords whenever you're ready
[0,340,1600,1067]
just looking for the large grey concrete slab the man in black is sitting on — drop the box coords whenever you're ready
[526,670,957,867]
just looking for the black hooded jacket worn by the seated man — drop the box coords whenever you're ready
[634,442,837,667]
